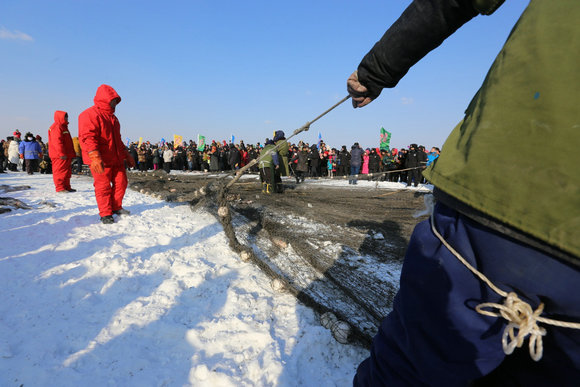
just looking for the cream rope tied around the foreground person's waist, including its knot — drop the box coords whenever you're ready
[426,201,580,361]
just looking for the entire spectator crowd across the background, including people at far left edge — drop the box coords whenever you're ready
[0,130,440,186]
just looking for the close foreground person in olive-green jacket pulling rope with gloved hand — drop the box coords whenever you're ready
[347,0,580,386]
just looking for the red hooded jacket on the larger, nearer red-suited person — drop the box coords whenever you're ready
[79,85,128,167]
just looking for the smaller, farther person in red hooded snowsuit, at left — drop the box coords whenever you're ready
[48,110,76,193]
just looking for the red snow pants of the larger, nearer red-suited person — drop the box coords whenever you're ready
[91,164,127,217]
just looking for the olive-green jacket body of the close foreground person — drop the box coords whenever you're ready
[424,0,580,257]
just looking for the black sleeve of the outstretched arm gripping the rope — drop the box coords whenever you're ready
[358,0,477,99]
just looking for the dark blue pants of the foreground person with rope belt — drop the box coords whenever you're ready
[354,204,580,386]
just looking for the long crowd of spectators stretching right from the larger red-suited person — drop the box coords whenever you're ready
[124,135,440,185]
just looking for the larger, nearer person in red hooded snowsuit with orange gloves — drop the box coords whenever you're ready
[79,85,135,224]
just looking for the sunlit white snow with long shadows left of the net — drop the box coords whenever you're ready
[0,172,374,387]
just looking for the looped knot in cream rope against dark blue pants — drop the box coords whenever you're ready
[475,292,546,361]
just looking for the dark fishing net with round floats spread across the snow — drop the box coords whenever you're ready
[153,171,430,347]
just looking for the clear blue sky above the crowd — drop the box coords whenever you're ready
[0,0,528,147]
